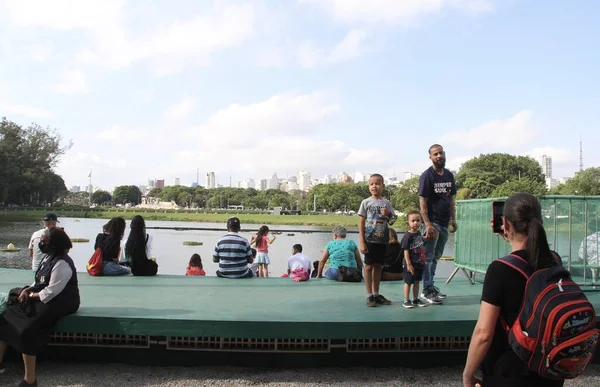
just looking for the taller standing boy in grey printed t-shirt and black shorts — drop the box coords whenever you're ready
[358,173,397,307]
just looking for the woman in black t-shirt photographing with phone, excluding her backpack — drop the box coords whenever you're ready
[463,193,564,387]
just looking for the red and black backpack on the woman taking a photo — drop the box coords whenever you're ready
[499,255,600,379]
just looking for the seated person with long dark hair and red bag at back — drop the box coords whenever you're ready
[94,216,131,276]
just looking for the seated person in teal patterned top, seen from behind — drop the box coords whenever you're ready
[317,226,363,280]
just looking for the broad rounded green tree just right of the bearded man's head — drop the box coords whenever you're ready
[456,153,545,198]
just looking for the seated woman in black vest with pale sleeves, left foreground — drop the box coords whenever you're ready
[0,228,80,386]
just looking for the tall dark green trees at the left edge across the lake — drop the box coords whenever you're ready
[0,117,72,206]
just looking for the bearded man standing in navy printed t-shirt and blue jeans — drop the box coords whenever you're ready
[419,144,457,304]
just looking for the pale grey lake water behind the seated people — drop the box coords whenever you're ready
[0,218,454,277]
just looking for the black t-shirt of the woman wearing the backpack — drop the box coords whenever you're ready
[481,250,563,387]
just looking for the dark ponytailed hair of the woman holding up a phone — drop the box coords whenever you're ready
[504,192,556,270]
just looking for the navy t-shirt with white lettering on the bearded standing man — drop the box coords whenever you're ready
[419,167,456,227]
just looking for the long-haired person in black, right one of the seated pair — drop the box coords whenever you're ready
[125,215,158,277]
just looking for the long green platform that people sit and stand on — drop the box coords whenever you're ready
[0,269,600,351]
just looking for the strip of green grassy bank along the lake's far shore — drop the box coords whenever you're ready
[0,208,404,230]
